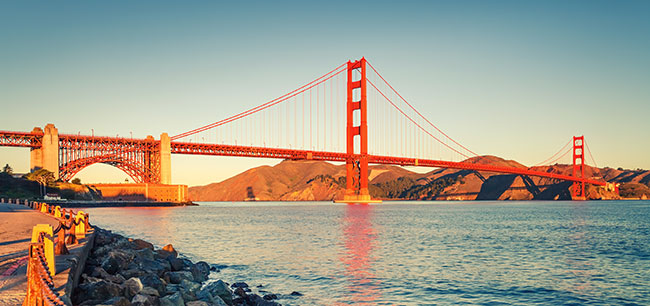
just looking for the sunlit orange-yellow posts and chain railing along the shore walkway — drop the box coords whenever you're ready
[0,198,91,306]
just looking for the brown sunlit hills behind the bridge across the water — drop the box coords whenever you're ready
[189,156,650,201]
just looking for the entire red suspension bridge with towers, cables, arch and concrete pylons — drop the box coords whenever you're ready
[0,58,611,202]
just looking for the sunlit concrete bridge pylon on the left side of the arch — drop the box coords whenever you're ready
[29,123,59,180]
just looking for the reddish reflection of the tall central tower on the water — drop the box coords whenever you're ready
[338,204,380,305]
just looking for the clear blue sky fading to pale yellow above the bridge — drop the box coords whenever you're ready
[0,1,650,185]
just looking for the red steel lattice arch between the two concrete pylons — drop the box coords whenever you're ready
[59,155,148,183]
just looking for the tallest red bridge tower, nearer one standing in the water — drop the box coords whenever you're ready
[343,58,378,203]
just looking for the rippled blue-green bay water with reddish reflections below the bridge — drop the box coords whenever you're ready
[87,201,650,305]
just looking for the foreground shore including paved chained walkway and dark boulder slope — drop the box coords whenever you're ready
[0,200,284,306]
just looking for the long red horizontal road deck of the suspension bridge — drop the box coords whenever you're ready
[0,131,607,186]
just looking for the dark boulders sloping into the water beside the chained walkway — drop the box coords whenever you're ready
[72,227,280,306]
